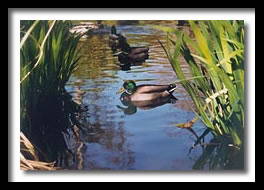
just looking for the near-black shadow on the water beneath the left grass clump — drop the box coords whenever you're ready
[22,88,86,166]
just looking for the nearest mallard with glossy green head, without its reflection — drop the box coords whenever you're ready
[117,80,176,101]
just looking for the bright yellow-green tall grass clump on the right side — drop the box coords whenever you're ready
[156,20,244,147]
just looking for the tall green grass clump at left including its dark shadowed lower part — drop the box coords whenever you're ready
[20,20,81,163]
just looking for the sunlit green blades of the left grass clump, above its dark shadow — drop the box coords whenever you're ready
[20,20,81,134]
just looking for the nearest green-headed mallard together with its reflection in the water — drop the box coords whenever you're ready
[117,81,177,115]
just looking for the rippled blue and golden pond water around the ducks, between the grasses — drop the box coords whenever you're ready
[64,25,212,170]
